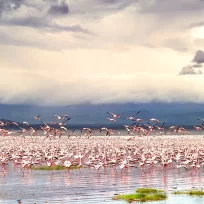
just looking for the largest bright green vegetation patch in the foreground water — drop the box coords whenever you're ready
[113,188,167,203]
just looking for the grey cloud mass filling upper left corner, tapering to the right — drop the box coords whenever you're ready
[0,0,93,34]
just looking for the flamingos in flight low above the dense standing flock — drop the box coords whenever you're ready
[0,111,204,138]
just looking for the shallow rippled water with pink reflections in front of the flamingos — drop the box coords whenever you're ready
[0,165,204,204]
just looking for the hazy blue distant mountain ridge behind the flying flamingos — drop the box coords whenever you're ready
[0,103,204,125]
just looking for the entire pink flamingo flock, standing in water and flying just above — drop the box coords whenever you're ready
[0,111,204,174]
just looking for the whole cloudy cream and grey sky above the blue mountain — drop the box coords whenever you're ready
[0,0,204,106]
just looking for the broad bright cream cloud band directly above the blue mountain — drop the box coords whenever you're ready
[0,44,204,106]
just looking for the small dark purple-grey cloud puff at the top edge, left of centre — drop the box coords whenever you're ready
[48,1,69,15]
